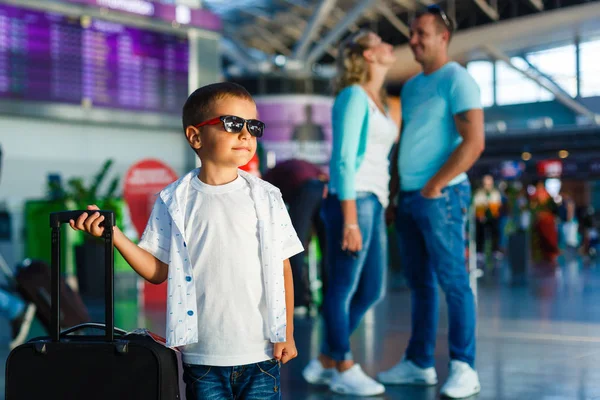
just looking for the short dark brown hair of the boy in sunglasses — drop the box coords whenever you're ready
[181,82,254,132]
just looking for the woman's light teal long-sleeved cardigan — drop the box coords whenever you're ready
[329,85,369,200]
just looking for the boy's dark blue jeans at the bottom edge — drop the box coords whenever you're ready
[183,359,281,400]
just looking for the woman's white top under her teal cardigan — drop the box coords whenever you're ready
[355,96,398,208]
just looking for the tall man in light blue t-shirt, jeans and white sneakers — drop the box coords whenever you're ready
[379,6,484,398]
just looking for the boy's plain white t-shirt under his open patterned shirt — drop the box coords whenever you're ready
[181,176,272,366]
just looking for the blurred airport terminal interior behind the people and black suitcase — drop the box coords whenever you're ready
[0,0,600,400]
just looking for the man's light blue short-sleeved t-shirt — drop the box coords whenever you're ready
[398,62,482,191]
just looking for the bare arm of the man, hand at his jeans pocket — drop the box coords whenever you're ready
[421,109,485,198]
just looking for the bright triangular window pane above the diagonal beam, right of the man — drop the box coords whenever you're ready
[526,44,577,97]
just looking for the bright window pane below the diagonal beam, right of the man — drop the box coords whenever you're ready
[496,57,554,105]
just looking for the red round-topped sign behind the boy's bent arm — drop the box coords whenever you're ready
[123,159,177,308]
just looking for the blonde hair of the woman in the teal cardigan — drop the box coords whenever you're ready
[333,29,387,106]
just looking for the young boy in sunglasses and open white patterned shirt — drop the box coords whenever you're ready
[71,83,303,400]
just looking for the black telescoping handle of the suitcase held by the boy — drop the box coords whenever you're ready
[50,210,115,342]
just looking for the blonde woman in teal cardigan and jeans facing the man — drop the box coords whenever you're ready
[303,30,398,396]
